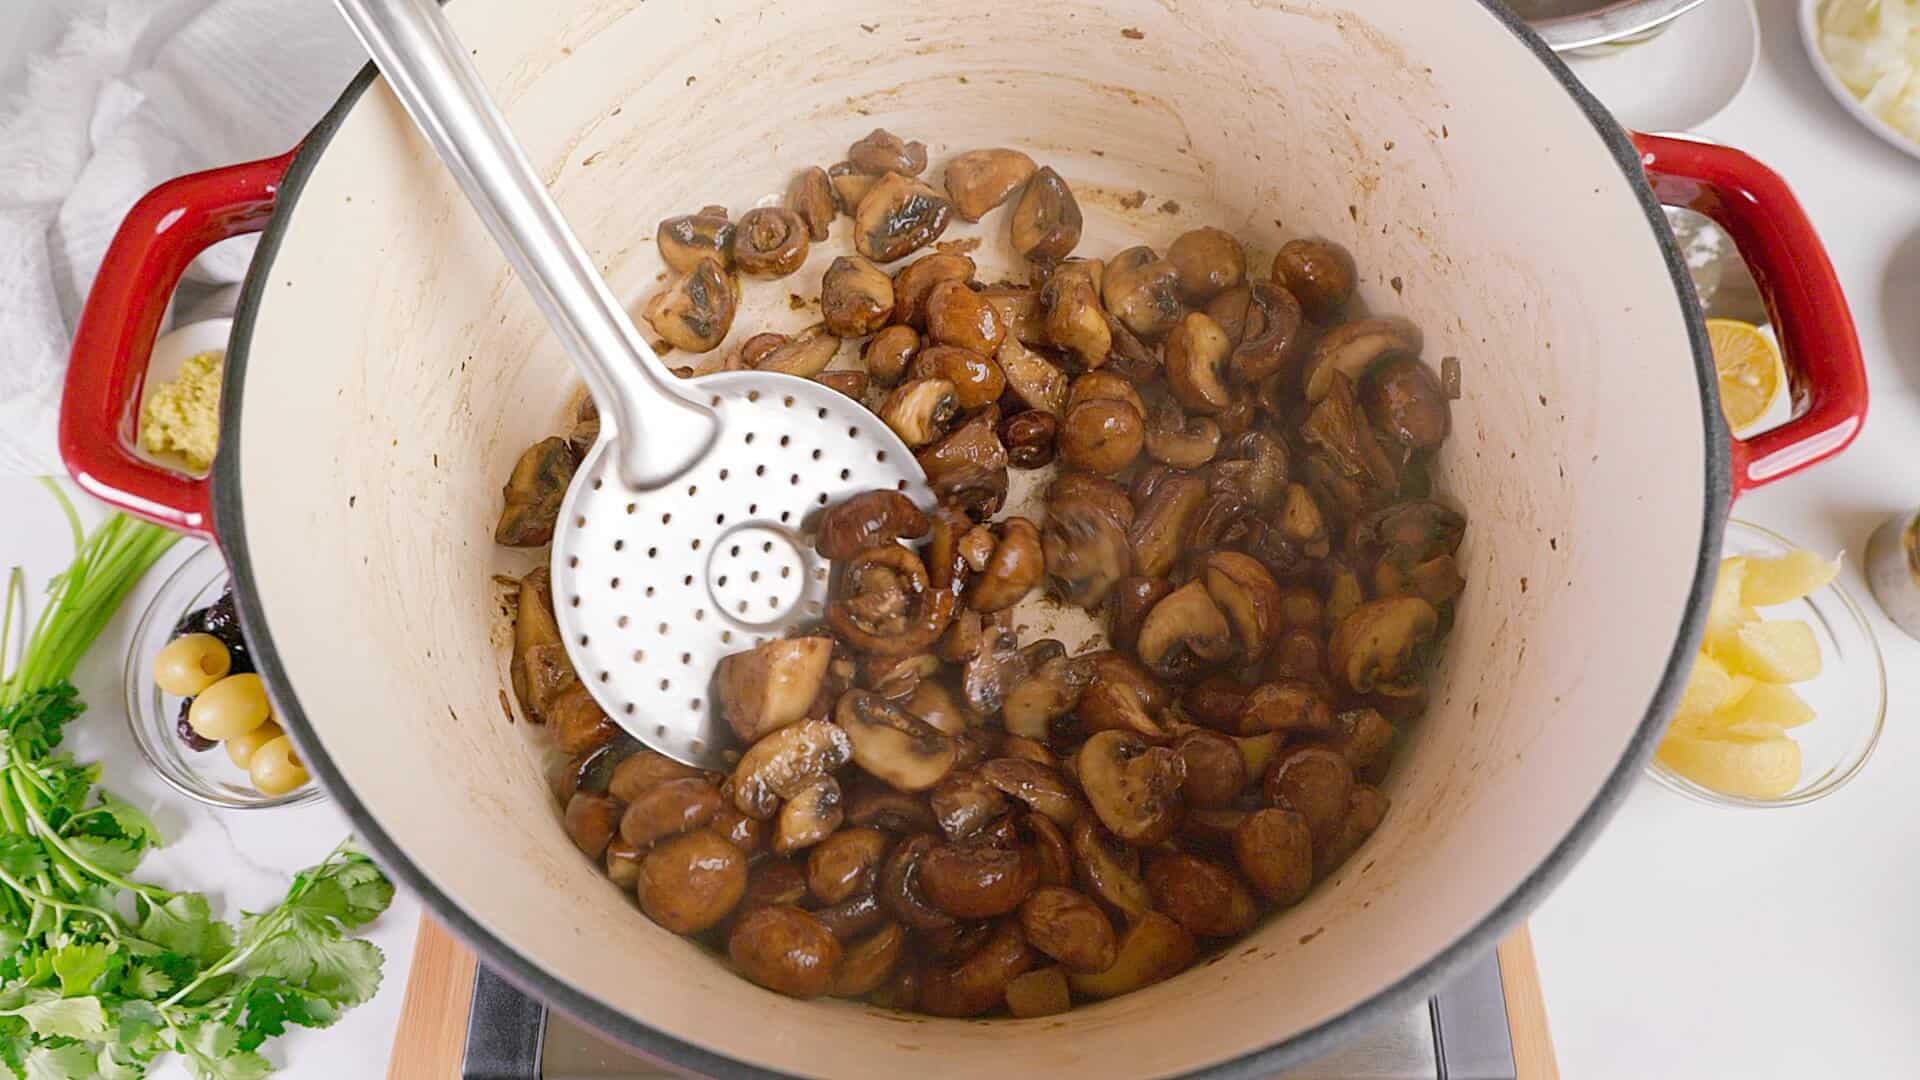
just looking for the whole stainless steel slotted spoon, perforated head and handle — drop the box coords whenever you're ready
[336,0,931,769]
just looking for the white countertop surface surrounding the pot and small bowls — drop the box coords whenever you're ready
[0,0,1920,1080]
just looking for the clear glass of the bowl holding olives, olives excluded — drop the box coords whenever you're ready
[121,544,326,809]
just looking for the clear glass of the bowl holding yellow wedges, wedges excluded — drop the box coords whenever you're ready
[1647,521,1887,809]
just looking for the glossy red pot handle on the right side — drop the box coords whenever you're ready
[1634,135,1866,500]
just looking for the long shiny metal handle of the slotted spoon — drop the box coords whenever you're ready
[336,0,720,490]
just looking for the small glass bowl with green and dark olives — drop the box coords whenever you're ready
[125,544,326,809]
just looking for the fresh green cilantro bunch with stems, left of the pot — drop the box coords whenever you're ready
[0,488,394,1080]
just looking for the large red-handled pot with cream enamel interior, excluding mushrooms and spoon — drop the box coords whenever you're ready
[61,0,1864,1076]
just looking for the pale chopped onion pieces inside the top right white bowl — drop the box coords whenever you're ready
[1818,0,1920,142]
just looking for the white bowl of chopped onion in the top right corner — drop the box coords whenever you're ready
[1801,0,1920,158]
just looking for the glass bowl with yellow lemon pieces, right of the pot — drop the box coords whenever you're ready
[1647,521,1887,807]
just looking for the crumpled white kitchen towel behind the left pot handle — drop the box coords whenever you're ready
[0,0,365,475]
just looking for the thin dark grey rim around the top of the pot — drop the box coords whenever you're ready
[213,0,1732,1080]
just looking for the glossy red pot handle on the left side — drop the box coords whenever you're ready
[60,150,294,538]
